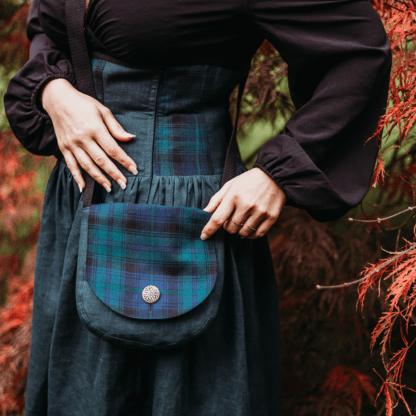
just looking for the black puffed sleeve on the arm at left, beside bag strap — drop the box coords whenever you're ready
[4,0,76,157]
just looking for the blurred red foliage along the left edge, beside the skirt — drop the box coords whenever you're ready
[0,53,50,416]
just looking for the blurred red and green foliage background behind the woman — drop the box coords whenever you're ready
[0,0,416,416]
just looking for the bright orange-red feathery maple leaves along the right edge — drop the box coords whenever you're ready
[352,0,416,416]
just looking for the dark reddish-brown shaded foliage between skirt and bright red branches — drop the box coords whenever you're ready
[269,207,382,416]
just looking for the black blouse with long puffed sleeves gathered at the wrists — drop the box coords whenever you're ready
[4,0,391,221]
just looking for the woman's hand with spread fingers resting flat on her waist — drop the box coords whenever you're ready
[42,78,137,192]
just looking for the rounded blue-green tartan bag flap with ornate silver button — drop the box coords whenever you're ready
[82,203,217,319]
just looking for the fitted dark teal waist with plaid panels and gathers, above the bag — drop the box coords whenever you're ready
[87,58,244,208]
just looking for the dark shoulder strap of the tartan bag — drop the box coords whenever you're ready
[65,0,248,208]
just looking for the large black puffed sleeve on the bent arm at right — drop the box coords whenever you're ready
[249,0,392,222]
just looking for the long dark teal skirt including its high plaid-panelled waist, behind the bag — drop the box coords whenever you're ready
[25,59,281,416]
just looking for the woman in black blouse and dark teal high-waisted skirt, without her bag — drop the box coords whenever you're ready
[5,0,391,416]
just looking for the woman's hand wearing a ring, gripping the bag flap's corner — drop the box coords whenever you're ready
[201,168,286,240]
